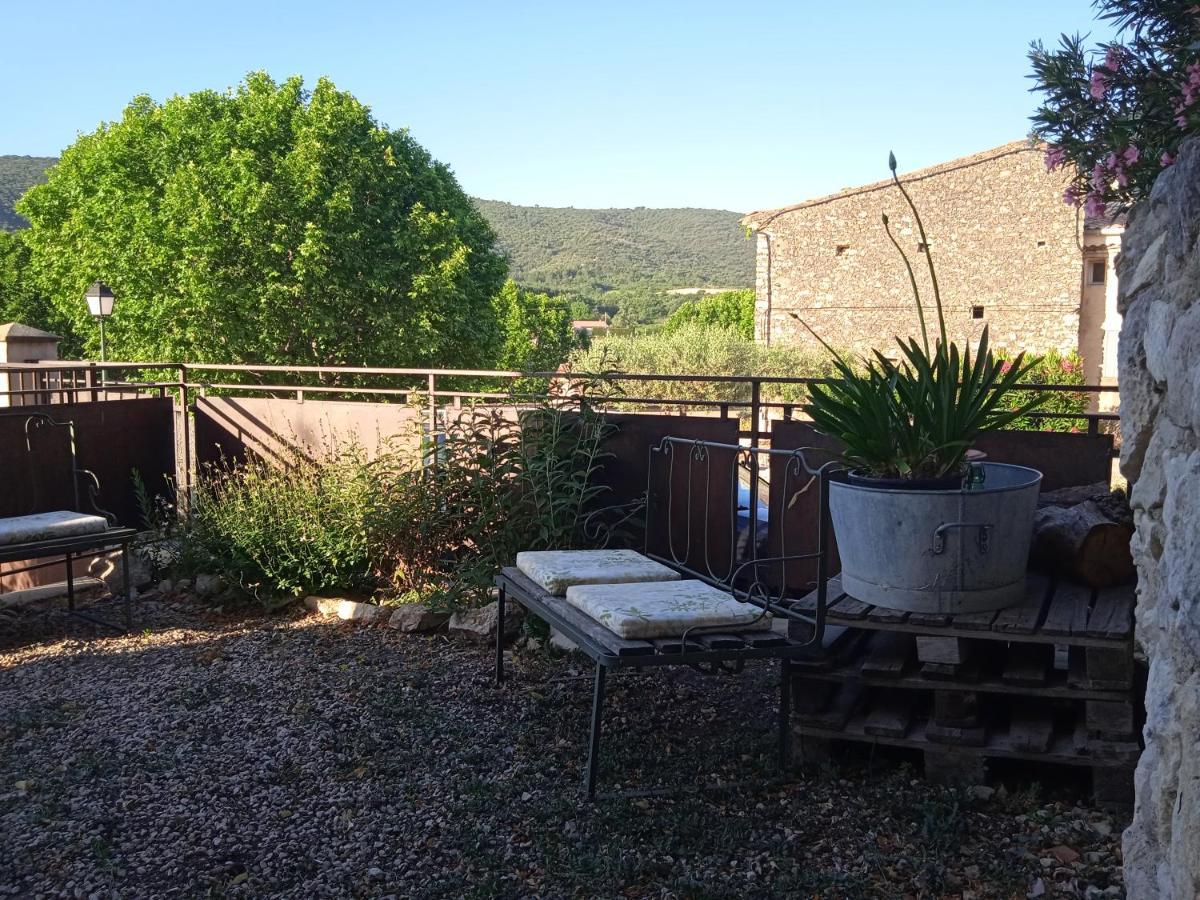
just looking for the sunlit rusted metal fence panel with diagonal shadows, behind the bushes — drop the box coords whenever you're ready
[194,397,421,467]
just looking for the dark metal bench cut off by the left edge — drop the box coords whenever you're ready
[0,413,137,632]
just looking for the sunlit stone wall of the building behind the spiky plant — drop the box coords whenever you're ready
[744,142,1082,352]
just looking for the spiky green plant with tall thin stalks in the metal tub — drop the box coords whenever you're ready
[792,154,1042,480]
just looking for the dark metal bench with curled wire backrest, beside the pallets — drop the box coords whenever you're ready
[496,437,834,800]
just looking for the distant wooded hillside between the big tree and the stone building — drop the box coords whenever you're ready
[475,200,754,296]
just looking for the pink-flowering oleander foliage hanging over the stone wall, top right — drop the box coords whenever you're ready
[1030,0,1200,215]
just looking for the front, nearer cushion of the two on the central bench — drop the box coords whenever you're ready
[566,580,770,640]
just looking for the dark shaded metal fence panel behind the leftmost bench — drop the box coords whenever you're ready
[0,397,175,527]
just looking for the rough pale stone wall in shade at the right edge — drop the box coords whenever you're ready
[1117,140,1200,900]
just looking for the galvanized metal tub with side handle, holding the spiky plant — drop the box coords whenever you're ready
[829,462,1042,614]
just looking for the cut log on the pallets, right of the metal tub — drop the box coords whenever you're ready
[1031,500,1135,588]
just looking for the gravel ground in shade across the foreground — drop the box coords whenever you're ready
[0,599,1123,899]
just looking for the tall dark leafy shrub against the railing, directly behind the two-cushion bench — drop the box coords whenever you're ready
[368,385,611,607]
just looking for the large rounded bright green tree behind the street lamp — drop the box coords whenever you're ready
[18,72,506,366]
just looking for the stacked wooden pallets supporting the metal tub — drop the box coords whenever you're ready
[793,575,1141,805]
